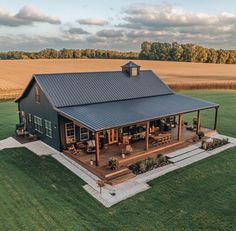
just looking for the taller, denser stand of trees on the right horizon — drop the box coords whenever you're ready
[139,41,236,64]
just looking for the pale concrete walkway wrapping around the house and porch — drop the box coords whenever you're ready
[0,134,236,207]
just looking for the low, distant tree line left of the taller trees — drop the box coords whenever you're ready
[0,48,139,60]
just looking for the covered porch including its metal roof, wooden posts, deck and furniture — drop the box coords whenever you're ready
[59,94,219,180]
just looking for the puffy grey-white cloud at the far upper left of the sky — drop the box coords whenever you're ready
[0,6,61,27]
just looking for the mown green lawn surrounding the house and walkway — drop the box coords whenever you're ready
[0,91,236,231]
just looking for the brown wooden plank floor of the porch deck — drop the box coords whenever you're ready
[65,126,213,178]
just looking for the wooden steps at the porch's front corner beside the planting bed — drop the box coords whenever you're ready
[104,168,135,185]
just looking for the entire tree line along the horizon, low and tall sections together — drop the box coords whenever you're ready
[0,41,236,64]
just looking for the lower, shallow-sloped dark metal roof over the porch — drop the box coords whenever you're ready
[58,94,218,131]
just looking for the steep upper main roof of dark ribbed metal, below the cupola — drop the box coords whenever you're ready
[34,70,173,107]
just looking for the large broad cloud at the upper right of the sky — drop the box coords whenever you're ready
[119,5,236,29]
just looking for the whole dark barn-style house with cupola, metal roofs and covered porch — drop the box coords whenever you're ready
[16,61,219,184]
